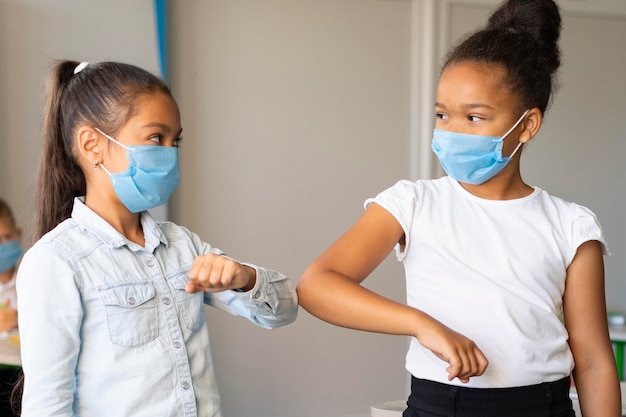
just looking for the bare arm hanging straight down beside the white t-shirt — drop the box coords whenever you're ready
[563,240,622,417]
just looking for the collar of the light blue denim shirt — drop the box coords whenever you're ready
[72,197,168,253]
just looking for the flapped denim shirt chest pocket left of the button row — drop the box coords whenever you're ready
[98,281,159,347]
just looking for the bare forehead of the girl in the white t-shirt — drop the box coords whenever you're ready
[436,62,517,108]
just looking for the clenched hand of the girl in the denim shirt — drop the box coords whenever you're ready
[185,253,256,293]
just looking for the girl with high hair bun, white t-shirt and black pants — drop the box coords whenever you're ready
[297,0,621,417]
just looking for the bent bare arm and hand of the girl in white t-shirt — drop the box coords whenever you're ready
[296,204,488,382]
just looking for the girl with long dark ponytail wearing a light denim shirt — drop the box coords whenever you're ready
[17,61,298,417]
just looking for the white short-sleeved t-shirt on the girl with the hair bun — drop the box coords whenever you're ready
[365,177,608,388]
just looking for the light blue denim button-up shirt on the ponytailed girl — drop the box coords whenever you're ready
[17,199,298,417]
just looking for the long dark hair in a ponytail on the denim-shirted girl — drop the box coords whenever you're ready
[35,61,171,239]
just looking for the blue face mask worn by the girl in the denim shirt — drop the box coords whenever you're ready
[95,128,180,213]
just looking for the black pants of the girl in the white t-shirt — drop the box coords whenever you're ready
[402,377,575,417]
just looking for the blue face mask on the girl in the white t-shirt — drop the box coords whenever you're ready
[432,110,528,185]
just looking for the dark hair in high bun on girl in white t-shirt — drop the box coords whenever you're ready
[443,0,561,113]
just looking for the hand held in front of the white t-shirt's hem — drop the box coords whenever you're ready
[416,320,489,383]
